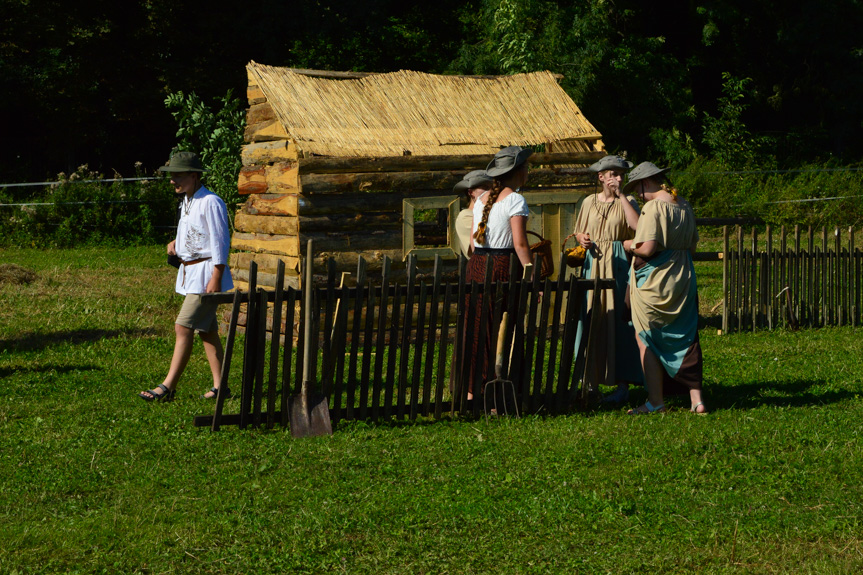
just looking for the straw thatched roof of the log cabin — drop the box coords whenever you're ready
[247,62,602,157]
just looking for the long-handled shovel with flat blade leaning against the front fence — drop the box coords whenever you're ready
[288,240,333,437]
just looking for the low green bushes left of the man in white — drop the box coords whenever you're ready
[0,165,176,247]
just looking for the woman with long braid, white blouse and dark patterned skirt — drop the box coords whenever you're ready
[464,146,533,399]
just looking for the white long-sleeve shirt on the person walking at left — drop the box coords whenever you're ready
[174,186,234,295]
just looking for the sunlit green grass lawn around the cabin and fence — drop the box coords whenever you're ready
[0,247,863,574]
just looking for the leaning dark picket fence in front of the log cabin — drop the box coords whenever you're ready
[195,257,613,430]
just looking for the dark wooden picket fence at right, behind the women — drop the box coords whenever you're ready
[722,226,863,333]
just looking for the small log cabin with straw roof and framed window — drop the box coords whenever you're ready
[230,62,605,290]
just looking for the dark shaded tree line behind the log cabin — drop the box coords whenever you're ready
[0,0,863,182]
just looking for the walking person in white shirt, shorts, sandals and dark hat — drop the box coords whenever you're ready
[138,152,234,401]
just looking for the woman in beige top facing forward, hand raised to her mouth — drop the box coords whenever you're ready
[575,156,643,403]
